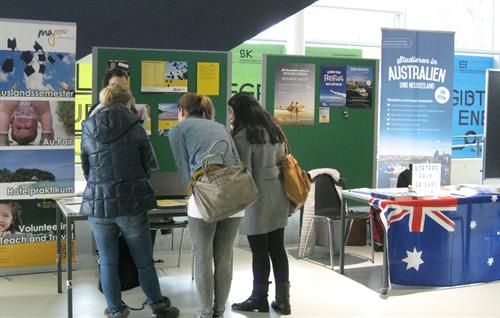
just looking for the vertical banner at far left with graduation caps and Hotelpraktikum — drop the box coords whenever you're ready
[0,19,76,269]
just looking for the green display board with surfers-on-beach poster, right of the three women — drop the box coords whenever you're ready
[262,55,378,188]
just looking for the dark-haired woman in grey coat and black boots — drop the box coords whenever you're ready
[228,93,292,315]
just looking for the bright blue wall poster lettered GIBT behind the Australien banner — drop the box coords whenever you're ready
[452,55,493,158]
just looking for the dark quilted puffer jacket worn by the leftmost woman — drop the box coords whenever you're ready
[81,105,158,218]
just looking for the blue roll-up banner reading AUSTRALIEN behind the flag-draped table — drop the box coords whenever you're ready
[377,29,454,187]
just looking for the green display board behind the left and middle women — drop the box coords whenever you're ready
[92,48,231,171]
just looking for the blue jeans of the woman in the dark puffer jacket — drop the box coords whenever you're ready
[89,213,163,314]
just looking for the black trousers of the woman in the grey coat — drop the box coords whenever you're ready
[247,228,289,284]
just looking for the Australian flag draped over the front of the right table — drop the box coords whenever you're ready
[370,193,500,286]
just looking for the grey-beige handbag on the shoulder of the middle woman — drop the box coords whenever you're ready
[193,139,258,223]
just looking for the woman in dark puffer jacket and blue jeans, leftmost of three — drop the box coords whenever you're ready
[81,84,179,318]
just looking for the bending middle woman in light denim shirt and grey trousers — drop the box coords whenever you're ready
[168,93,244,318]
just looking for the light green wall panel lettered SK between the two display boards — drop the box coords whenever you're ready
[231,44,285,100]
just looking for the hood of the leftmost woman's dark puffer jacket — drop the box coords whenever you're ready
[87,105,141,143]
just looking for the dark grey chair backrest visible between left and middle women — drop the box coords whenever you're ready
[149,170,187,199]
